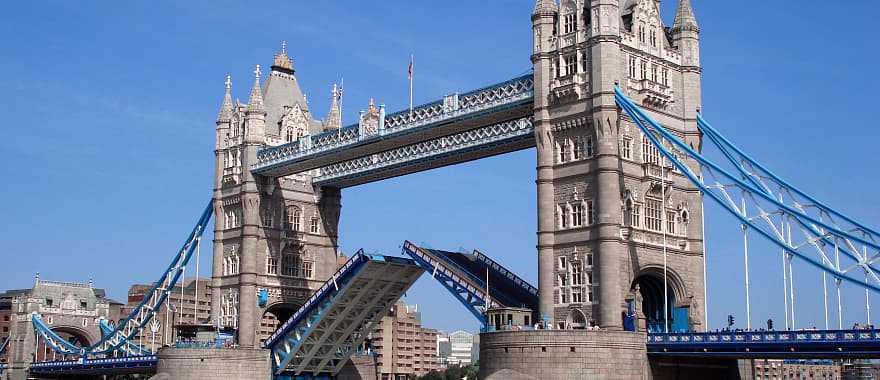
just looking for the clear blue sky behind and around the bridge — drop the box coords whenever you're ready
[0,0,880,330]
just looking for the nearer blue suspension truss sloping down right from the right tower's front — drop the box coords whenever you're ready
[615,88,880,292]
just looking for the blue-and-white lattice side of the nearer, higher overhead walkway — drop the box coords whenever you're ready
[251,74,534,174]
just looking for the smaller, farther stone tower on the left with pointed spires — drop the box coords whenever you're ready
[212,46,341,347]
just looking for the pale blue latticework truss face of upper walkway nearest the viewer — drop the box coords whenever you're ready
[250,74,534,176]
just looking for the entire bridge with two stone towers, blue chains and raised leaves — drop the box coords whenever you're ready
[0,0,880,379]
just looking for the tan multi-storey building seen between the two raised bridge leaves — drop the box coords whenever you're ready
[370,302,440,380]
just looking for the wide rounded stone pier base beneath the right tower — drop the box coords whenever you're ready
[480,330,652,380]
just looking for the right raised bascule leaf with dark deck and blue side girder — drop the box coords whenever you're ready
[403,241,538,326]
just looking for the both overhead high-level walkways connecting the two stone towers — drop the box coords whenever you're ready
[250,74,535,188]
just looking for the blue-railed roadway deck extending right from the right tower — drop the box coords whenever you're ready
[647,330,880,358]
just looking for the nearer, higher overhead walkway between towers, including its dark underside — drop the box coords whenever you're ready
[250,74,534,177]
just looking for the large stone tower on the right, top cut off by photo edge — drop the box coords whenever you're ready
[532,0,705,330]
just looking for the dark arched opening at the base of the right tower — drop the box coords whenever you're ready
[633,271,689,332]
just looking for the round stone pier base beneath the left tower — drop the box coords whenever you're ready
[151,348,272,380]
